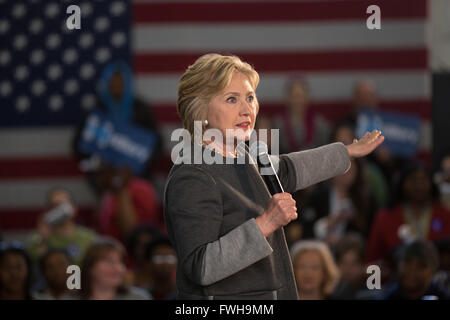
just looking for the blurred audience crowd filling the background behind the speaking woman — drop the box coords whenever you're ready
[0,73,450,300]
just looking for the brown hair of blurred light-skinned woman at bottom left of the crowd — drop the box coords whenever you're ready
[79,237,128,299]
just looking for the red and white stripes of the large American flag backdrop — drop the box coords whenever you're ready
[0,0,430,228]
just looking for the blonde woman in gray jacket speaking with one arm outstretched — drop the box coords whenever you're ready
[164,54,384,299]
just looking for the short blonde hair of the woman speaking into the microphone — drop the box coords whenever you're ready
[177,53,259,135]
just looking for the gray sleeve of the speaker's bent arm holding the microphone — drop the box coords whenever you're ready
[165,165,273,286]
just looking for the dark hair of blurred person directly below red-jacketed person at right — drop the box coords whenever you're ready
[397,240,439,272]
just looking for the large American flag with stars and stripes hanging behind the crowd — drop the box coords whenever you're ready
[0,0,430,229]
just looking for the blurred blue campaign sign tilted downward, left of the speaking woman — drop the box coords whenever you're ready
[79,111,156,174]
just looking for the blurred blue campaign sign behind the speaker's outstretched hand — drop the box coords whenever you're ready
[356,111,421,157]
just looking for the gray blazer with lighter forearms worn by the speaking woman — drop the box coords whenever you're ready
[164,143,350,300]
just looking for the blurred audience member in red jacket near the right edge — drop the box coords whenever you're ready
[366,164,450,273]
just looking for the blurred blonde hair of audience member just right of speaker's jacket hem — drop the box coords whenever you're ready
[291,240,340,296]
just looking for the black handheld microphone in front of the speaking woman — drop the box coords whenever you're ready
[250,141,284,195]
